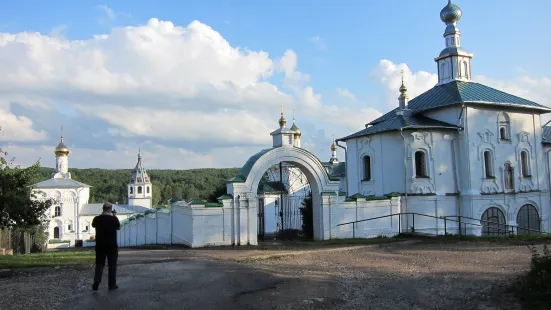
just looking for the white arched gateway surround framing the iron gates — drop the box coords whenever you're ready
[228,146,339,244]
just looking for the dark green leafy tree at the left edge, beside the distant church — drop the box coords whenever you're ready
[0,149,54,229]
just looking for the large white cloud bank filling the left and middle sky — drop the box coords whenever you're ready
[0,18,378,168]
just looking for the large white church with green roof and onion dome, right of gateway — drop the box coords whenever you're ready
[337,1,551,235]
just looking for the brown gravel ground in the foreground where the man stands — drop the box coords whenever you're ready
[0,242,530,309]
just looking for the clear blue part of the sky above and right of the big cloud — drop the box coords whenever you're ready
[0,0,551,170]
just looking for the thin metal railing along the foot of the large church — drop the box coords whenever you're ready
[333,212,549,238]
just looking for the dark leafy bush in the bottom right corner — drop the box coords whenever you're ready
[511,245,551,309]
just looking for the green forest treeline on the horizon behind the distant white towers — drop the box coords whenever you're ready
[36,167,239,205]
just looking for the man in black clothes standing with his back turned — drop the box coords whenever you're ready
[92,202,121,291]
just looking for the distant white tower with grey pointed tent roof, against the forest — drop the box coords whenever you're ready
[128,150,153,209]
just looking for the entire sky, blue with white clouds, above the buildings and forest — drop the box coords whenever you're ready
[0,0,551,169]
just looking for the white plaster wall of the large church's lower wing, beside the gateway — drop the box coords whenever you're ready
[347,130,456,196]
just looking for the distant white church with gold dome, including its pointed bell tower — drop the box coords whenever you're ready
[33,135,152,247]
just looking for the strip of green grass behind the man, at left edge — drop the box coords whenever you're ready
[0,249,96,269]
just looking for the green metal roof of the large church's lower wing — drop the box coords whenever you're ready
[337,112,459,141]
